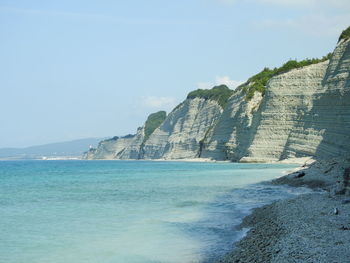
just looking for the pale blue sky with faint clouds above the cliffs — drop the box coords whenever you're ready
[0,0,350,148]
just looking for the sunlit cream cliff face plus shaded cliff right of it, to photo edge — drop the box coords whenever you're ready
[246,40,350,161]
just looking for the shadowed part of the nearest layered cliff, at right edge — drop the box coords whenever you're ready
[307,39,350,158]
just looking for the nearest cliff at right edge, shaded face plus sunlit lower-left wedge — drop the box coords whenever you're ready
[286,40,350,158]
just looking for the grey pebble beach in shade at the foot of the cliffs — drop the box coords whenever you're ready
[218,159,350,263]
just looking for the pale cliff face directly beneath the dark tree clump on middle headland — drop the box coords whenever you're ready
[142,98,222,159]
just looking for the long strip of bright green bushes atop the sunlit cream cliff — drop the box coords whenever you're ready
[238,53,332,101]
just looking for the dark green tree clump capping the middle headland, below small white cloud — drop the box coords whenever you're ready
[187,85,233,108]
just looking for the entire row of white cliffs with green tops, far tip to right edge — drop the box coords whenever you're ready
[87,31,350,162]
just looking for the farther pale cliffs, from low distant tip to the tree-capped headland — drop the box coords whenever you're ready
[85,98,222,159]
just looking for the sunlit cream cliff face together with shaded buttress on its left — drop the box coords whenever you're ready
[202,61,328,162]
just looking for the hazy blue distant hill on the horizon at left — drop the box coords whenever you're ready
[0,138,104,159]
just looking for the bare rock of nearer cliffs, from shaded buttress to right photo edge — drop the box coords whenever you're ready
[201,40,350,162]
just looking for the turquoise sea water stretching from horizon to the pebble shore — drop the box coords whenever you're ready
[0,161,312,263]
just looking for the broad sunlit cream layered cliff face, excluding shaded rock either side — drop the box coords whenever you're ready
[241,61,328,162]
